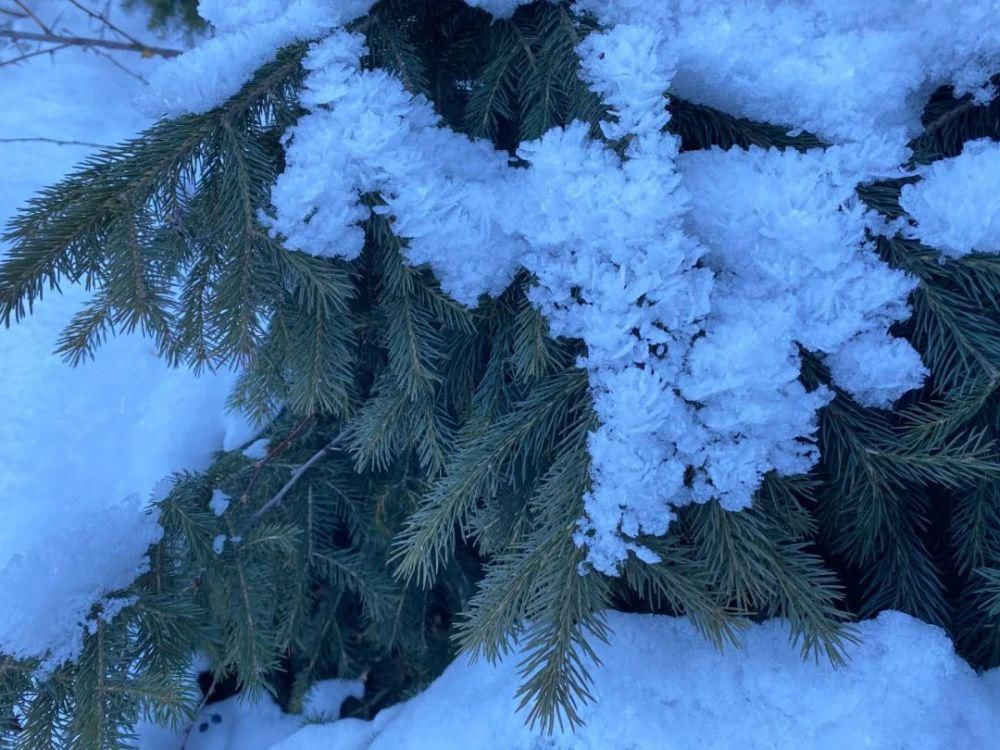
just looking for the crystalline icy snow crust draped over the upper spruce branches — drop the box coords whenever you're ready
[139,0,1000,573]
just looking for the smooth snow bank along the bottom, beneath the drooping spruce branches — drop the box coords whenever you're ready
[156,612,1000,750]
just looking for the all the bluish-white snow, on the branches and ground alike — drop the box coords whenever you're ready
[0,0,1000,750]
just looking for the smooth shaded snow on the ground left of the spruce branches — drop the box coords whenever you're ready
[0,0,251,662]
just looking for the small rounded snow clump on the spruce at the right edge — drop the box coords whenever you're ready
[899,138,1000,258]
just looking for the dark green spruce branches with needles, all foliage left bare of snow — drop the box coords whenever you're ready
[0,0,1000,750]
